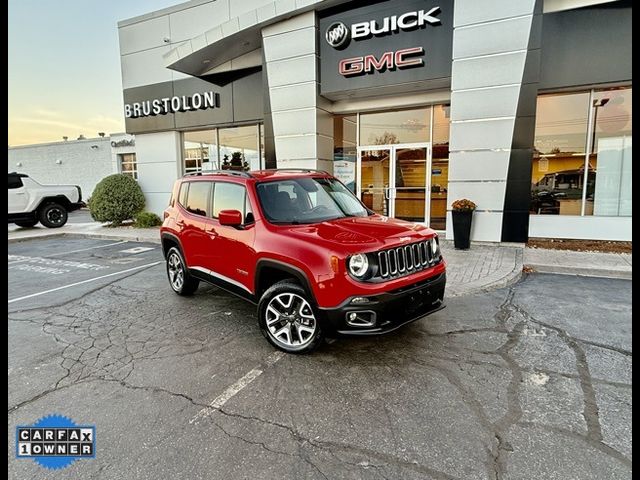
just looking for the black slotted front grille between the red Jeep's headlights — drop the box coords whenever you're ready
[374,238,442,279]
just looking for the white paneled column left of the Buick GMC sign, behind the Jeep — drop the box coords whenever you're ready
[262,12,333,172]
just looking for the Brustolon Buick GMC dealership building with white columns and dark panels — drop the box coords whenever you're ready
[118,0,632,242]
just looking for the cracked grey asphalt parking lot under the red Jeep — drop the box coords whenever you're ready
[8,238,632,479]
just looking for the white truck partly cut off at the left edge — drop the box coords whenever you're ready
[8,172,85,228]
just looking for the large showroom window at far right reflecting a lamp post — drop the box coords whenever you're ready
[530,87,632,216]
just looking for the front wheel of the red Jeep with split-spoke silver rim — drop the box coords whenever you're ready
[258,280,323,353]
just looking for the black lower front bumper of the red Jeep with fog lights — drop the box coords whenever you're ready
[319,272,446,336]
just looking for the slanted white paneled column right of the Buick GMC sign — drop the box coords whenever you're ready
[447,0,541,242]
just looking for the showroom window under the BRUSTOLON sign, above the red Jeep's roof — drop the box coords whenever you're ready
[183,124,264,173]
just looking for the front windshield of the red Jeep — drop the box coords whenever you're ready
[256,177,371,225]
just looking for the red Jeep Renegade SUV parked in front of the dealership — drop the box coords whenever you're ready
[161,169,445,352]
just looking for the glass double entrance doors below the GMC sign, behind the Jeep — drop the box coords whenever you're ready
[356,143,431,223]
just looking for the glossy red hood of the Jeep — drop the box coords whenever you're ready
[286,215,435,254]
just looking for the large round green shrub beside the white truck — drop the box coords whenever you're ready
[89,173,144,226]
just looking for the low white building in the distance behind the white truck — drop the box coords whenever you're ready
[7,133,138,199]
